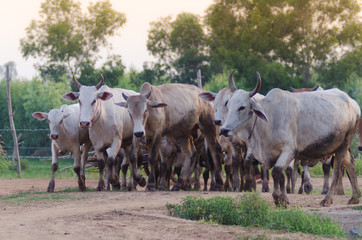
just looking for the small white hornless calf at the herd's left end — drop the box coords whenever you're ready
[32,104,91,192]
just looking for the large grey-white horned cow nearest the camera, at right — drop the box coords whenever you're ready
[221,74,361,206]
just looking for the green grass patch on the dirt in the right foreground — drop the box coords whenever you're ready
[166,193,345,237]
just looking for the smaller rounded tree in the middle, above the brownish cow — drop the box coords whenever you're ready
[147,13,209,84]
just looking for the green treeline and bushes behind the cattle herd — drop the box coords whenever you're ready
[0,0,362,158]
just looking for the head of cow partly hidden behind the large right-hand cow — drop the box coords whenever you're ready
[199,70,236,126]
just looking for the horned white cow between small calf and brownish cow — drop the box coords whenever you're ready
[63,76,146,191]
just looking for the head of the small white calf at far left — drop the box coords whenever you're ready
[32,109,70,140]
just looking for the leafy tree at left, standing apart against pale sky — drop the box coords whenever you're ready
[20,0,126,81]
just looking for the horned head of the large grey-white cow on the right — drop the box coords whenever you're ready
[220,73,267,140]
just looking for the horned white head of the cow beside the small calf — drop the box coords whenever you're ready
[63,75,113,128]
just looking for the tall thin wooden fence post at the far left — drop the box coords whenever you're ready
[6,65,21,177]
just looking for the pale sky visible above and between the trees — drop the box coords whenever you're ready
[0,0,213,79]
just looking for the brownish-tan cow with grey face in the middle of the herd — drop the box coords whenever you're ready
[119,82,223,191]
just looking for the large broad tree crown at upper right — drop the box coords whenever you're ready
[205,0,362,85]
